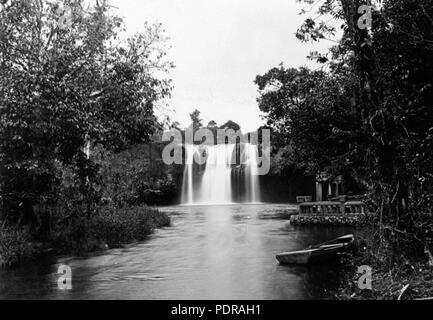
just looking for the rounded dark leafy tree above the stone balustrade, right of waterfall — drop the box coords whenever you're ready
[255,65,361,175]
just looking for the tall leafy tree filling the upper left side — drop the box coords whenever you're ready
[0,0,171,229]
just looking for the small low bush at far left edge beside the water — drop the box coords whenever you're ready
[0,223,32,268]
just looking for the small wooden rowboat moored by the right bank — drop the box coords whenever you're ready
[276,234,355,264]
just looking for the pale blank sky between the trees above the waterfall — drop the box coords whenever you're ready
[110,0,329,132]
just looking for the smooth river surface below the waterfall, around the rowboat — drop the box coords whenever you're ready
[0,204,352,299]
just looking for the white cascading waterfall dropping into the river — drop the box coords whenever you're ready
[181,143,260,205]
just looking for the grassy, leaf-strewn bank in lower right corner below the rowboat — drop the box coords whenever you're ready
[334,231,433,300]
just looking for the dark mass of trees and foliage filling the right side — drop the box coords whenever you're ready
[256,0,433,262]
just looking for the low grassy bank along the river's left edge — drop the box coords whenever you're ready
[0,206,170,268]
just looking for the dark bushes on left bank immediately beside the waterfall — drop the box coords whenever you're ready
[92,144,183,206]
